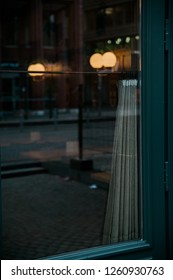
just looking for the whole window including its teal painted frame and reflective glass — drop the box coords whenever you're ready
[0,0,173,259]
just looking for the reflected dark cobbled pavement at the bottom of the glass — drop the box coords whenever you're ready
[2,174,107,260]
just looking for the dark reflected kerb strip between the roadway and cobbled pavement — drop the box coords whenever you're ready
[1,154,110,189]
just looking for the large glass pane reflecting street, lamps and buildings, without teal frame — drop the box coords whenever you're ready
[0,0,142,259]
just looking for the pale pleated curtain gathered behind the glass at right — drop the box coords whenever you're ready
[103,80,139,244]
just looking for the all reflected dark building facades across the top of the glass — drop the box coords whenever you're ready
[0,0,138,115]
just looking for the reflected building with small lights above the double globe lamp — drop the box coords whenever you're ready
[84,0,139,70]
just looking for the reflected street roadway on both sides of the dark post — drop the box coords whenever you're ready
[0,121,114,171]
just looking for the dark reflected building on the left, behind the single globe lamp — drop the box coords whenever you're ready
[0,0,82,115]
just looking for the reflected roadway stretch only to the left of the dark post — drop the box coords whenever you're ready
[0,125,77,163]
